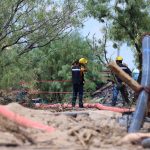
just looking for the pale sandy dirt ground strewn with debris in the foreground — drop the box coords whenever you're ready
[0,103,147,150]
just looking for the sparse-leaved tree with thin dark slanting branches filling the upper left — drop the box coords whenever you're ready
[0,0,81,56]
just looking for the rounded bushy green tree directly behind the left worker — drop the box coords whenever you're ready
[32,32,102,101]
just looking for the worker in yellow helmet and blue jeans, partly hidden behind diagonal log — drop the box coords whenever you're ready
[112,56,132,106]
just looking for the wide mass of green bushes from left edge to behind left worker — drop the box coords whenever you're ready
[0,32,102,102]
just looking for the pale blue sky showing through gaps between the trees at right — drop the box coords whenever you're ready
[80,18,135,70]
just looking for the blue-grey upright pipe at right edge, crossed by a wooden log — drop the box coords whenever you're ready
[128,35,150,133]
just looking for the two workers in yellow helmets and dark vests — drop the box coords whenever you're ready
[72,56,132,108]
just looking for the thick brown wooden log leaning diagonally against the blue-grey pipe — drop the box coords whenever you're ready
[108,62,142,93]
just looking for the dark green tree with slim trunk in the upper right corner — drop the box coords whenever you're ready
[86,0,150,82]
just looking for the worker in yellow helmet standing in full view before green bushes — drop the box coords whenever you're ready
[72,58,87,108]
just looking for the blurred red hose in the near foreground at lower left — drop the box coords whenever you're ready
[0,105,55,132]
